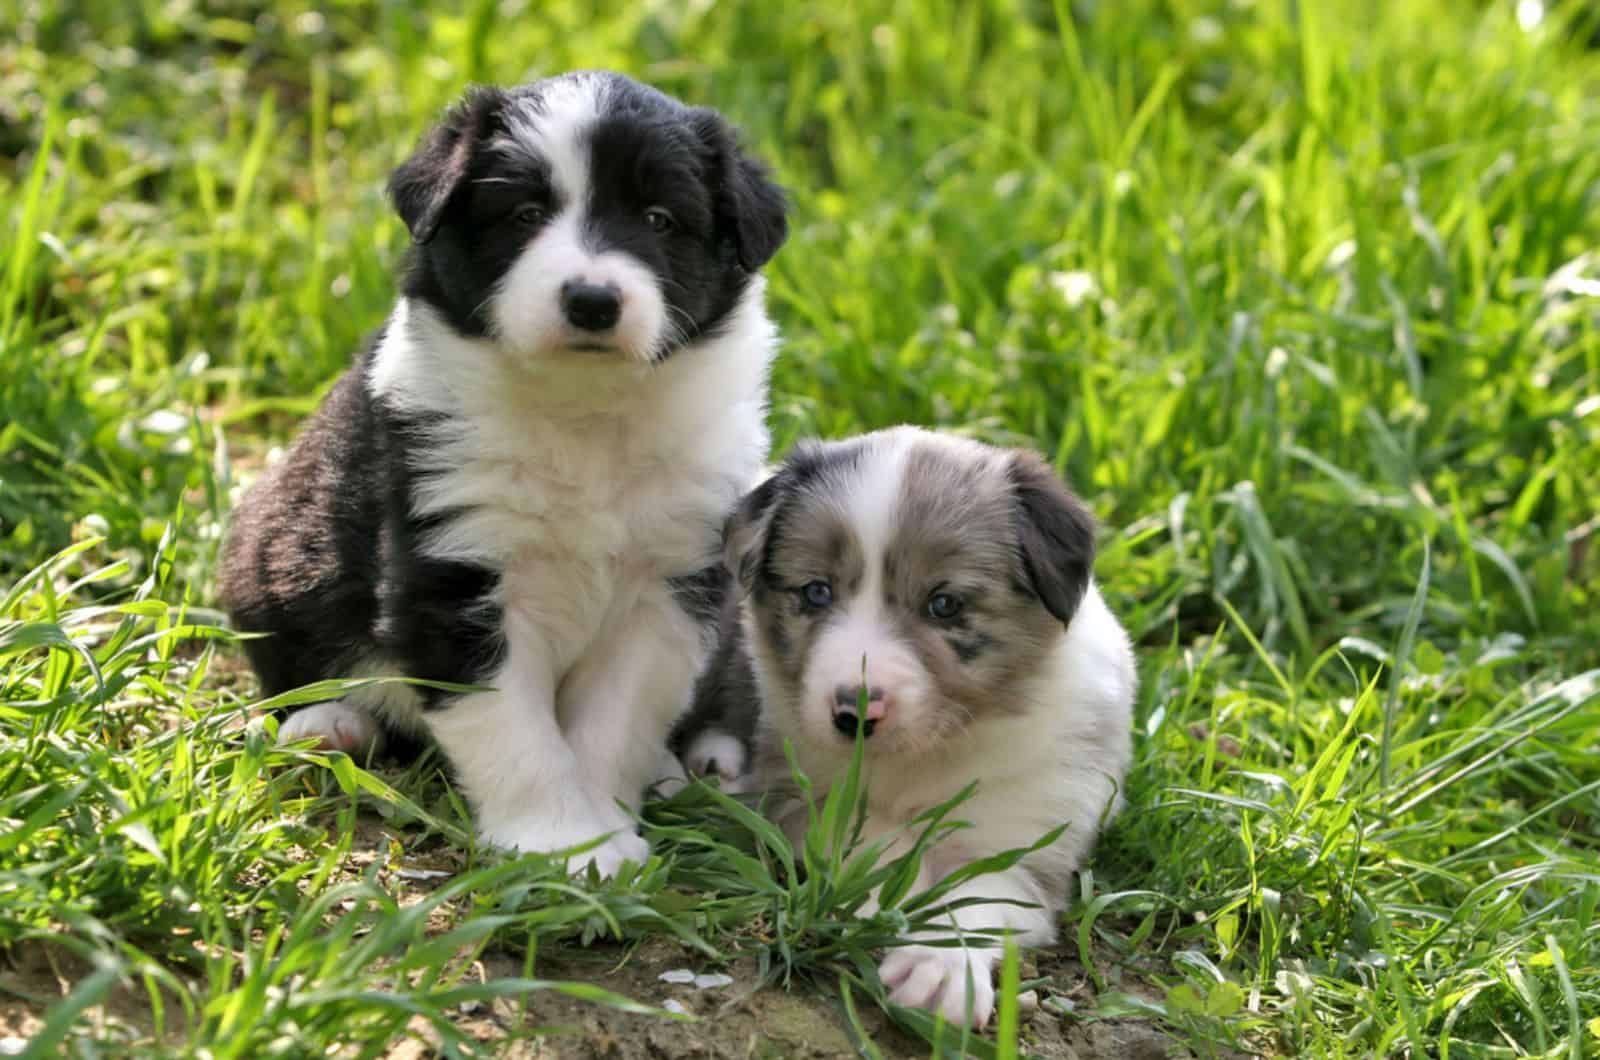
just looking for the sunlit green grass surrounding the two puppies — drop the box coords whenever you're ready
[0,0,1600,1058]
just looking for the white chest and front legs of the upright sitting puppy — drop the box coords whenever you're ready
[370,277,776,871]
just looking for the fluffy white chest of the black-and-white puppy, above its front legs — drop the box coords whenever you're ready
[371,293,776,671]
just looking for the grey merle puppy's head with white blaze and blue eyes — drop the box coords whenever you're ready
[728,428,1094,754]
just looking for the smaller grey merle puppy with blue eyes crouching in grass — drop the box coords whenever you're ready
[678,428,1136,1026]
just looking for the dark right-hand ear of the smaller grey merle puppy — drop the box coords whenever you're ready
[1008,450,1094,623]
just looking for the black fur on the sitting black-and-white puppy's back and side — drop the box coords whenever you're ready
[221,328,504,752]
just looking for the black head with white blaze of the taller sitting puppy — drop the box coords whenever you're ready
[390,72,786,363]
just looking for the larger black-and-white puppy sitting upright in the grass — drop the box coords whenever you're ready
[221,72,786,873]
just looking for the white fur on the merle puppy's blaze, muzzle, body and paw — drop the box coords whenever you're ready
[744,429,1138,1026]
